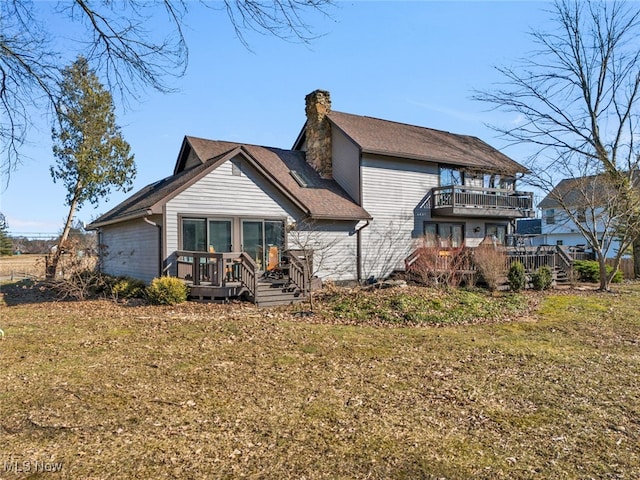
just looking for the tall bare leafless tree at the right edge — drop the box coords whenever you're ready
[475,0,640,290]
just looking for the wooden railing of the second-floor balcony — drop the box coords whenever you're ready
[431,185,533,211]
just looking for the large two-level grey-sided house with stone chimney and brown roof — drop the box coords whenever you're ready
[90,90,534,281]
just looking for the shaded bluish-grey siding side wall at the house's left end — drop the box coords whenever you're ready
[100,216,161,282]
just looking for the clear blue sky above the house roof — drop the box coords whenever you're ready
[0,1,552,232]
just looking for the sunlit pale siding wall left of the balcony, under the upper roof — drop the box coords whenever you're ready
[361,156,438,279]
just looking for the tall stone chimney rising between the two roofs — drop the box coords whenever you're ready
[304,90,332,178]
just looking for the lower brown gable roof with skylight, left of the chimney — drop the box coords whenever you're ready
[89,136,371,228]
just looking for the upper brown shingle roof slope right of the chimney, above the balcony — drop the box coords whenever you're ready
[327,111,528,175]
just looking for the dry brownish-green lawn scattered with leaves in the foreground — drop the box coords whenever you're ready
[0,284,640,479]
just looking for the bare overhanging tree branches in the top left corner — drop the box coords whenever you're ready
[0,0,332,178]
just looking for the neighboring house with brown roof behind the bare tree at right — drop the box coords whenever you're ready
[538,175,619,257]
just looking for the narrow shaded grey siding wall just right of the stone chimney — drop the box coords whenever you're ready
[331,127,361,203]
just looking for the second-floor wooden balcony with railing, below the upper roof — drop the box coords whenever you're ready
[431,185,535,218]
